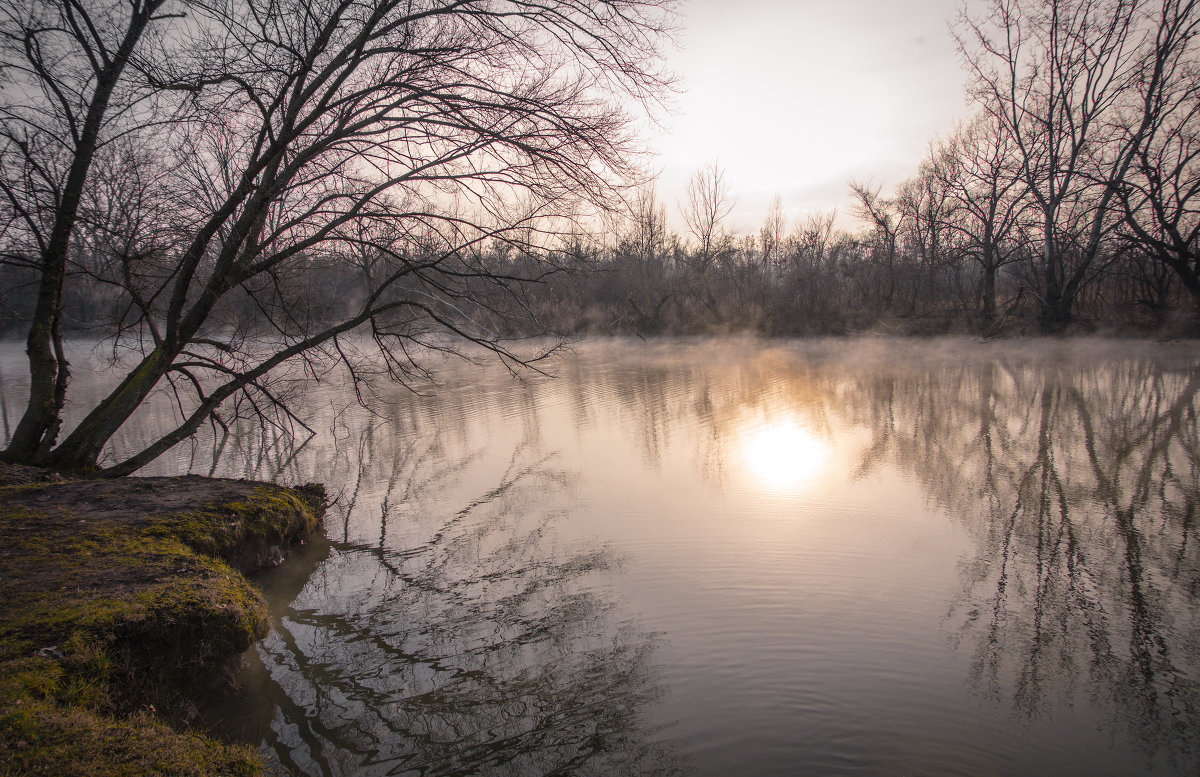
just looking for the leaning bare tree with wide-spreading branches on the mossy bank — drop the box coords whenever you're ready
[6,0,672,475]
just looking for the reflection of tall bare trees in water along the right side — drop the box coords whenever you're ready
[851,350,1200,764]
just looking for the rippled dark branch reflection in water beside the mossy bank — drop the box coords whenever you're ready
[211,416,682,775]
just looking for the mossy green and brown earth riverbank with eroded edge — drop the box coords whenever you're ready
[0,465,324,777]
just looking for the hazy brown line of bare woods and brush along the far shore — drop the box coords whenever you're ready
[0,164,1198,336]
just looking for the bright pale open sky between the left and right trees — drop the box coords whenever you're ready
[649,0,970,234]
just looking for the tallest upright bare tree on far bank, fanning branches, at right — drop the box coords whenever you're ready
[956,0,1150,330]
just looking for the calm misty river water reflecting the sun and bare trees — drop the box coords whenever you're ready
[0,338,1200,776]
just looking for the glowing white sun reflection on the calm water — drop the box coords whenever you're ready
[740,418,830,493]
